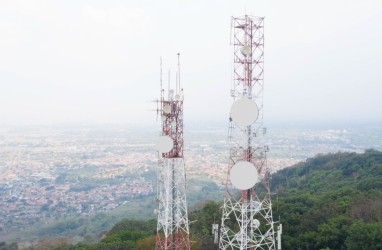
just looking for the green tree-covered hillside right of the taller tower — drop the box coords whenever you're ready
[271,150,382,249]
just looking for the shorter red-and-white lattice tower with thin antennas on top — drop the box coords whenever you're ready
[155,53,190,250]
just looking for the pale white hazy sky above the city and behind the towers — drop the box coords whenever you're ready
[0,0,382,127]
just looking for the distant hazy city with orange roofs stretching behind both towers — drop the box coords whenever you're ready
[0,124,382,239]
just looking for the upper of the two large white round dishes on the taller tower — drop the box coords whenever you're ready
[231,98,259,126]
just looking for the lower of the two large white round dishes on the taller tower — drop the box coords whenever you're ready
[230,161,259,190]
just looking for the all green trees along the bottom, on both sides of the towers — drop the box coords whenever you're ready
[0,150,382,250]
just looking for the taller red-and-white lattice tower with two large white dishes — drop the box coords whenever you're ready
[219,15,276,250]
